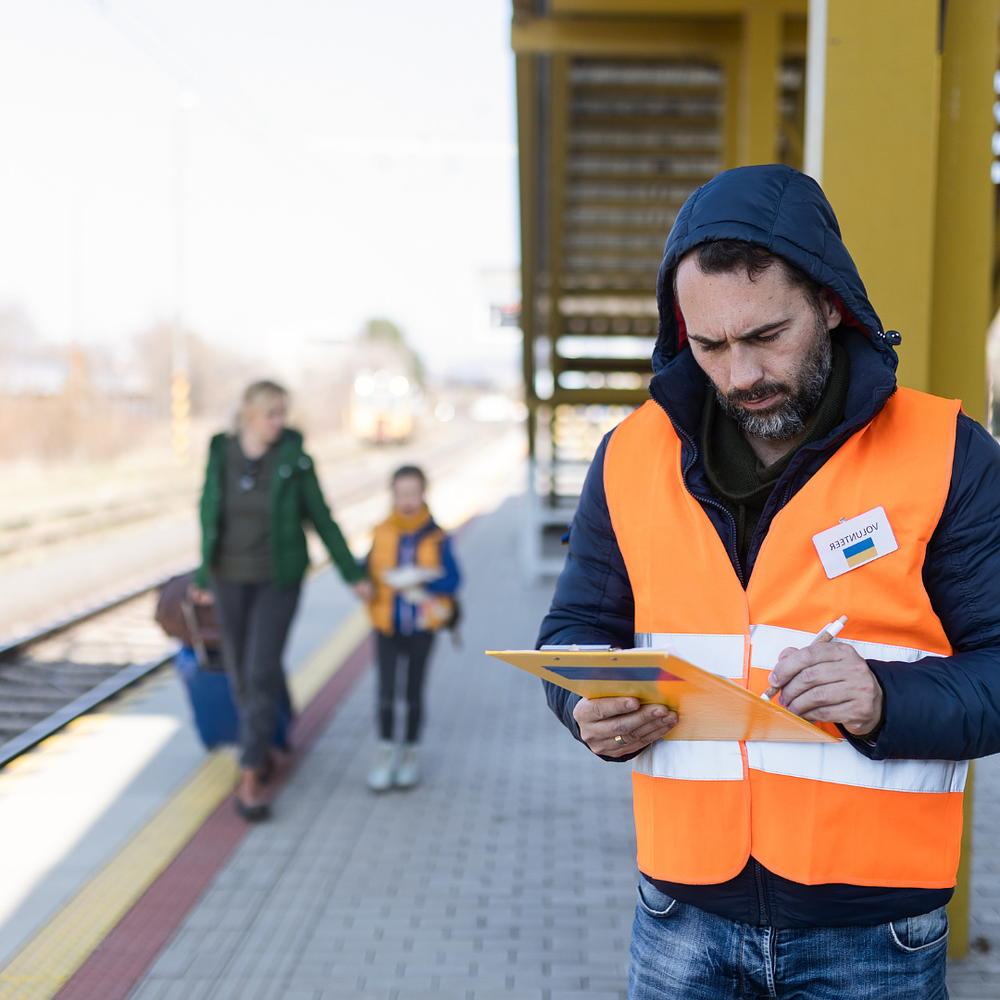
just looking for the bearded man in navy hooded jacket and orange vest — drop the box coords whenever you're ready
[539,166,1000,1000]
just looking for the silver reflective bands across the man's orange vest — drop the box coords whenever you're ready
[632,625,969,793]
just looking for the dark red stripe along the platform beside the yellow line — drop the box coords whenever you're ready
[56,636,374,1000]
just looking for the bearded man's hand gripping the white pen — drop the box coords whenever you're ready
[768,642,883,736]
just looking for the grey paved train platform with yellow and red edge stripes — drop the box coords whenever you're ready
[0,488,1000,1000]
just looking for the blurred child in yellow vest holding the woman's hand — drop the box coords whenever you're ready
[368,465,459,792]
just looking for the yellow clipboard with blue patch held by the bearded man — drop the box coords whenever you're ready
[486,647,839,743]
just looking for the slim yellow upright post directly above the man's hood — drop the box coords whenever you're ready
[737,0,782,166]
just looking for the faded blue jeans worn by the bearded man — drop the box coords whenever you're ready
[628,879,948,1000]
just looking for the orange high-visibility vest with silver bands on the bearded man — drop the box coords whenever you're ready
[604,389,968,888]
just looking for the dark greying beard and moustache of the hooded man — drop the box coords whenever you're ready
[712,322,833,441]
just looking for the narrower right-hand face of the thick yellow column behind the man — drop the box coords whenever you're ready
[930,0,998,420]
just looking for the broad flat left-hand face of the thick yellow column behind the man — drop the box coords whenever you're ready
[823,0,940,389]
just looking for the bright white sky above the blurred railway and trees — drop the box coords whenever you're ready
[0,0,518,376]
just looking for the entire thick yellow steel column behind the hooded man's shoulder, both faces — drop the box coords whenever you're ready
[823,0,998,957]
